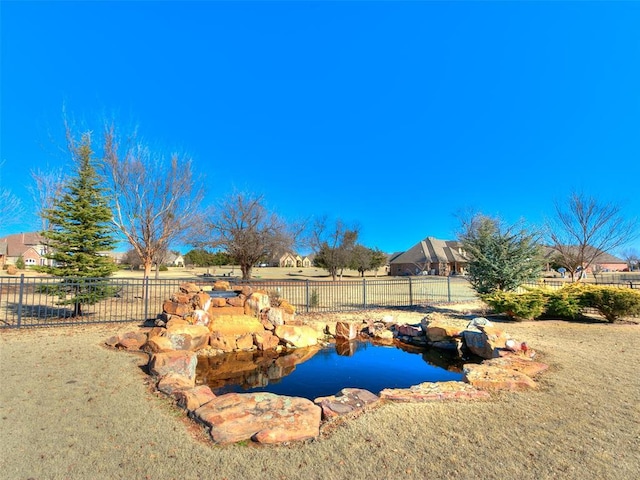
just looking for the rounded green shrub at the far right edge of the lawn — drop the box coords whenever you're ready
[581,285,640,323]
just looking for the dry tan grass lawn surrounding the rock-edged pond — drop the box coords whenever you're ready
[0,310,640,480]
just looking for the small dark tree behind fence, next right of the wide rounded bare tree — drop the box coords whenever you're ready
[308,217,360,281]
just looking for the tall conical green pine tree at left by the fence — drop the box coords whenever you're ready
[37,133,117,316]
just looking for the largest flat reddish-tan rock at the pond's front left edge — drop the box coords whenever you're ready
[194,393,321,444]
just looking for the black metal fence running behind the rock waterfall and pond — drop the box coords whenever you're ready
[0,275,476,328]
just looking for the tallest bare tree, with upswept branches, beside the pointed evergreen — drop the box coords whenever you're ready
[102,126,204,277]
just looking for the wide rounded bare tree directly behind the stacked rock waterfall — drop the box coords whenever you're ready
[200,192,298,280]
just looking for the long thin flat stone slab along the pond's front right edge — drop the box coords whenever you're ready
[380,382,490,402]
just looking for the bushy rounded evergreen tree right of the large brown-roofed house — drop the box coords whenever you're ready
[460,215,542,294]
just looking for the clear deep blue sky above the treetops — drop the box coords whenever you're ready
[0,1,640,252]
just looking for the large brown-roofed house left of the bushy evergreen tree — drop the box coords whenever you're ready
[389,237,467,276]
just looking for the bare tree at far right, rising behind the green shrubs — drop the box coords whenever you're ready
[546,193,638,281]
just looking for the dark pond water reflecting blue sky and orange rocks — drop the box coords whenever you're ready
[196,341,479,400]
